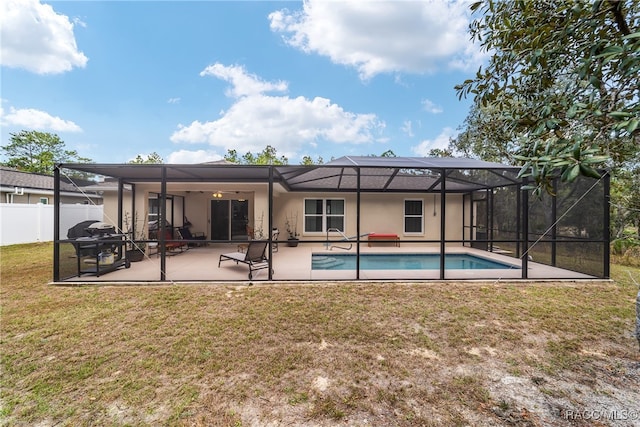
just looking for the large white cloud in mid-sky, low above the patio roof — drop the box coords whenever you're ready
[171,64,384,158]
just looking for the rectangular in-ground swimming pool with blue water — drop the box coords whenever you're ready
[311,253,520,270]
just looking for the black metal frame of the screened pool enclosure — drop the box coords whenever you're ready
[53,158,610,282]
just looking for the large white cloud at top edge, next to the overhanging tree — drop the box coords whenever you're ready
[269,0,484,80]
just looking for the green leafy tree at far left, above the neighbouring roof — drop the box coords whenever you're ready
[2,130,91,175]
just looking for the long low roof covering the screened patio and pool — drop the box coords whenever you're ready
[60,156,520,192]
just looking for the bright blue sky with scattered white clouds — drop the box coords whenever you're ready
[0,0,486,164]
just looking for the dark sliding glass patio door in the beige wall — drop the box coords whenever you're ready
[211,200,249,240]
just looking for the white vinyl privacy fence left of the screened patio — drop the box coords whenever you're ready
[0,203,104,246]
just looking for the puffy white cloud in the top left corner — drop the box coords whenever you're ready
[0,0,88,74]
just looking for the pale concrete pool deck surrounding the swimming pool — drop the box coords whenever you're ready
[59,242,594,284]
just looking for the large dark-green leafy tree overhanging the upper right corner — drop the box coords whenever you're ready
[455,0,640,196]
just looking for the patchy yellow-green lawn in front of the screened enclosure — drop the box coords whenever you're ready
[0,244,640,426]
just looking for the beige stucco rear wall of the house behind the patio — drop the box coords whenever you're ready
[104,184,470,244]
